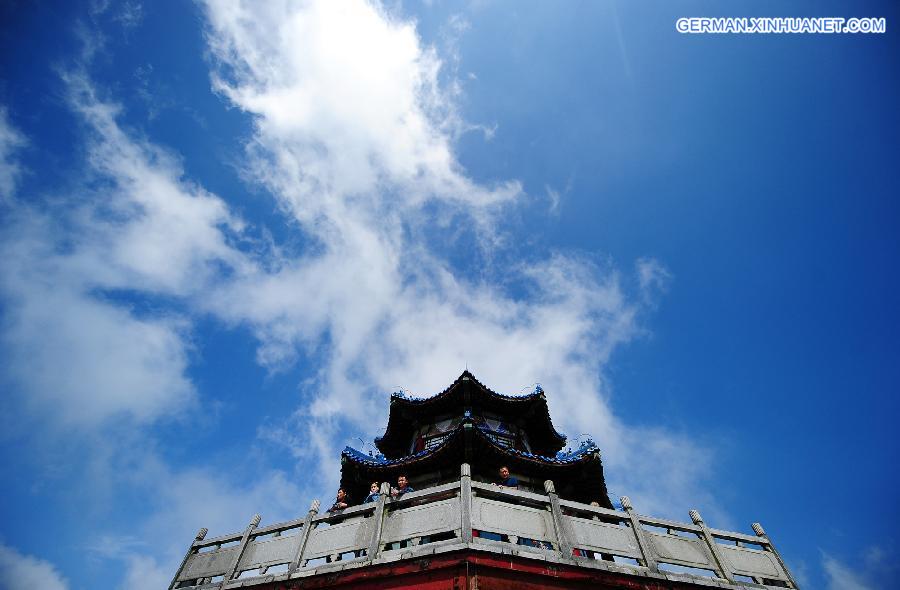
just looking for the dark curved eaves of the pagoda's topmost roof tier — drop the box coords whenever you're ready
[375,370,566,454]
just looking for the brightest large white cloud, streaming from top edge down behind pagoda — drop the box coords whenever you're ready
[197,0,714,512]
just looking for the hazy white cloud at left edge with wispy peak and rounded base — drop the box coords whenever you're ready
[0,74,243,426]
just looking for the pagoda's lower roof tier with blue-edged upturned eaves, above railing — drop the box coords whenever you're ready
[341,416,612,507]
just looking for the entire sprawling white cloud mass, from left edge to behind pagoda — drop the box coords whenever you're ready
[0,8,724,584]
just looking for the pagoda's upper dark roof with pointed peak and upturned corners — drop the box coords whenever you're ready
[375,370,566,459]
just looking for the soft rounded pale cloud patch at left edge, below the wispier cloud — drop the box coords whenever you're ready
[2,262,194,426]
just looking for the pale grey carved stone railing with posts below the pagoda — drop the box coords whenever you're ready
[170,464,797,590]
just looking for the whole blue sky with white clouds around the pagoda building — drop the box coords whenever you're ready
[0,0,900,589]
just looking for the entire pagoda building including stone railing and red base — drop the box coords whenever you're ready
[169,370,797,590]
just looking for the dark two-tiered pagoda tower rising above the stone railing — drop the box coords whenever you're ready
[341,370,612,508]
